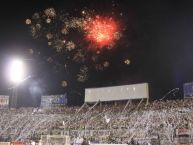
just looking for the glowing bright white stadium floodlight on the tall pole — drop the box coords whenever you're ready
[8,59,24,84]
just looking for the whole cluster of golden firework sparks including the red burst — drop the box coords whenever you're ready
[25,8,122,82]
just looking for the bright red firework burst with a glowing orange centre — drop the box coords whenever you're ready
[84,16,118,48]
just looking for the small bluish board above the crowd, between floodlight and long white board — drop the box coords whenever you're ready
[40,94,67,108]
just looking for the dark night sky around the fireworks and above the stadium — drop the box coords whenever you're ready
[0,0,193,106]
